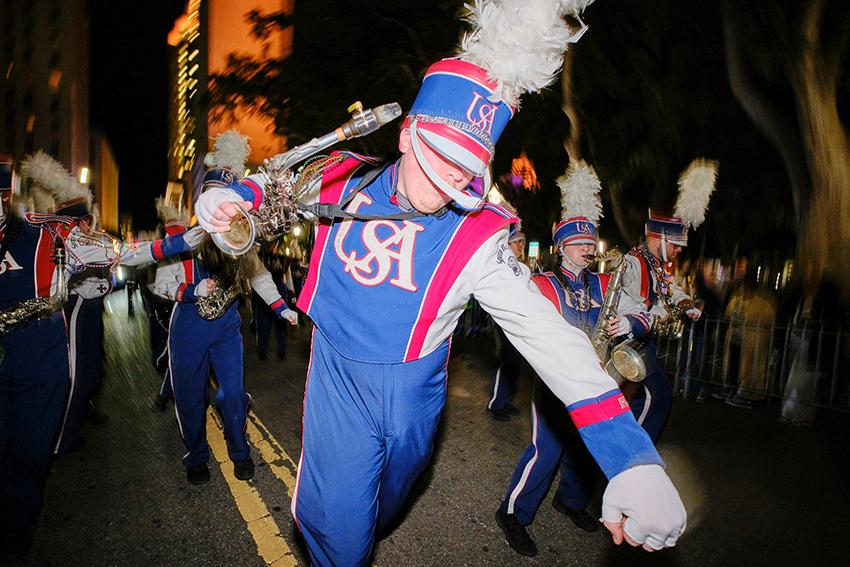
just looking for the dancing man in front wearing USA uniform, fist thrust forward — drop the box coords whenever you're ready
[196,0,685,565]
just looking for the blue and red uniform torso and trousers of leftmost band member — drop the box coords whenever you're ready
[0,215,73,531]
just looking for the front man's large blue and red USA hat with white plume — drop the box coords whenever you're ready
[404,0,593,209]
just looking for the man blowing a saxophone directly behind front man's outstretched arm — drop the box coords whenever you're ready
[496,162,648,556]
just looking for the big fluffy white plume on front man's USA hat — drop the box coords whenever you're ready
[459,0,593,106]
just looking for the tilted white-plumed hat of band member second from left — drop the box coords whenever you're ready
[21,150,92,217]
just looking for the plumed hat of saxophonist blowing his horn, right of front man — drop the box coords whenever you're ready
[552,161,602,246]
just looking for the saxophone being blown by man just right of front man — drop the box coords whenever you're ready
[590,248,646,385]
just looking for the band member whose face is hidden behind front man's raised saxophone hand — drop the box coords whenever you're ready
[165,130,297,484]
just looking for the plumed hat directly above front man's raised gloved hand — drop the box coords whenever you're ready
[203,129,263,207]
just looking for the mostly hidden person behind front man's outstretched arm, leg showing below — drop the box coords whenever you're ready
[487,223,527,421]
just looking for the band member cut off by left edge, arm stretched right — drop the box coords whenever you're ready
[0,152,200,556]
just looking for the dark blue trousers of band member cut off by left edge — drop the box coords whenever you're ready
[0,312,68,528]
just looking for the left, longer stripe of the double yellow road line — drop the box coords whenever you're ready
[207,409,298,567]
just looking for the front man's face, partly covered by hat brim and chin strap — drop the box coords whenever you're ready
[398,128,472,213]
